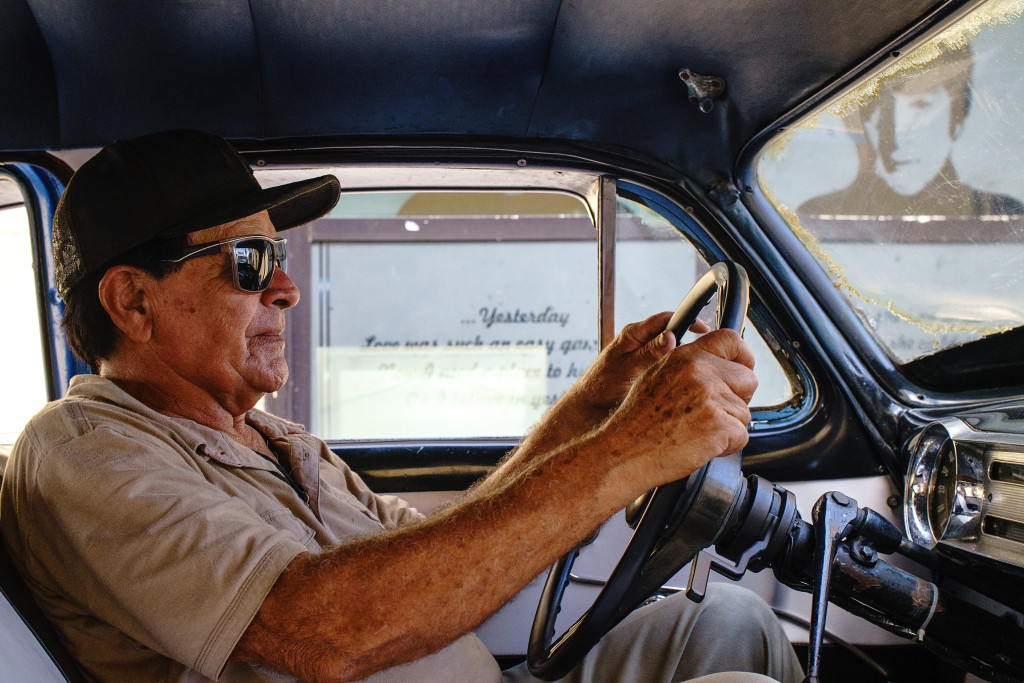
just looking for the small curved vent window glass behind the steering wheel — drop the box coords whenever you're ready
[614,198,795,409]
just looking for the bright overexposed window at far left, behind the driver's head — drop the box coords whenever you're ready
[0,171,46,450]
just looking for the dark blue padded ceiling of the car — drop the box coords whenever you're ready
[0,0,945,185]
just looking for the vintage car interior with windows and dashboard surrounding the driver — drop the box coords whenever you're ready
[0,0,1024,681]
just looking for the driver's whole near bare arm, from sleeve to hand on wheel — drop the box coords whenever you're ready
[232,331,757,681]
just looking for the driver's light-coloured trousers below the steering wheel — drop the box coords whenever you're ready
[504,583,804,683]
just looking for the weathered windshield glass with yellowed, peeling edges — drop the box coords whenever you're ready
[758,0,1024,364]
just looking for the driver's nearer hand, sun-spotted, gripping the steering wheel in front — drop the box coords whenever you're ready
[602,330,758,488]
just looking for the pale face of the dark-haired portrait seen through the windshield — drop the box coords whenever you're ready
[864,86,952,196]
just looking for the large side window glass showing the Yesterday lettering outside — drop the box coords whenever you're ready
[305,191,598,439]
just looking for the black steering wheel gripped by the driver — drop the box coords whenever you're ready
[527,261,749,681]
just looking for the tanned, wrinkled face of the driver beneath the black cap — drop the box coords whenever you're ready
[142,211,299,415]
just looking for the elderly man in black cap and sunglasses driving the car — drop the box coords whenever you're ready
[0,131,800,682]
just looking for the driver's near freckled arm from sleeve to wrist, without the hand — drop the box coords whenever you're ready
[234,432,626,680]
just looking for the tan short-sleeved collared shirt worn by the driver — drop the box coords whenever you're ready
[0,376,501,682]
